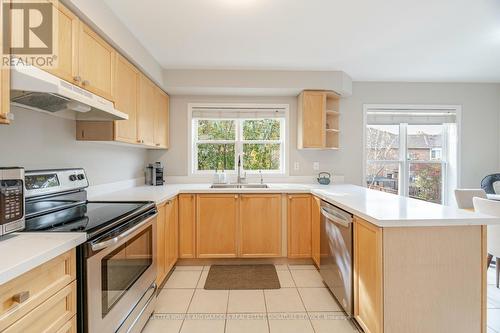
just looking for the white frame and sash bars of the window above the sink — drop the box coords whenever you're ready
[187,103,290,176]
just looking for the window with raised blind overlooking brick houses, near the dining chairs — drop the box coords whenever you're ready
[365,107,458,203]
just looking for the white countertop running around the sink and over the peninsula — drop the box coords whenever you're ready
[89,184,500,227]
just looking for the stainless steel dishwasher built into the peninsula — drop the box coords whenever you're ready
[320,201,354,317]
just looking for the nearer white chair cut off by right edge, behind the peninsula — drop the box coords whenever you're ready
[473,198,500,288]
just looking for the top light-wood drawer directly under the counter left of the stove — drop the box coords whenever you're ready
[0,250,76,331]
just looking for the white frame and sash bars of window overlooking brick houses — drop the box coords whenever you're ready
[362,104,462,205]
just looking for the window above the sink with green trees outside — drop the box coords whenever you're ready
[190,105,287,174]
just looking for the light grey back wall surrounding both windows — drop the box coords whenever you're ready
[149,82,500,187]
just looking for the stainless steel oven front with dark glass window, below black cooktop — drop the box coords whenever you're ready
[84,213,157,333]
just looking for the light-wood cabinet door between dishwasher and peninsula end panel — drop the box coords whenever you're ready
[354,217,383,333]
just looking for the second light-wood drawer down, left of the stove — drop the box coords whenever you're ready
[4,281,76,333]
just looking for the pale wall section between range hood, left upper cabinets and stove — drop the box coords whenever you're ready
[0,107,147,185]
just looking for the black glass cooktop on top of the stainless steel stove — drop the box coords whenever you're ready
[25,200,150,234]
